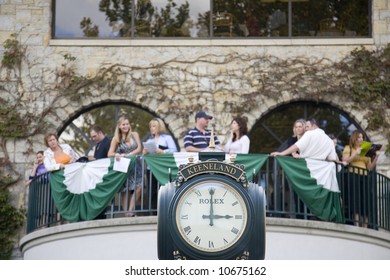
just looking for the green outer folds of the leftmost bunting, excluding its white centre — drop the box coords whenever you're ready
[50,157,135,222]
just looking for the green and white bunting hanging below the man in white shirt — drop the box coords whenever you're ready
[276,156,345,223]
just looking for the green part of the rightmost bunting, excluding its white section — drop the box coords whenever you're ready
[276,157,345,223]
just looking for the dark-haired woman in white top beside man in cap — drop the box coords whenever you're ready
[224,117,250,154]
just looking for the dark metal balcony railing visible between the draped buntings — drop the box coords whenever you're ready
[27,157,390,233]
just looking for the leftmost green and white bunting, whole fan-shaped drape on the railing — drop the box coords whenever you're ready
[50,157,135,222]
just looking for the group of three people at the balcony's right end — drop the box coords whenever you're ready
[271,119,380,227]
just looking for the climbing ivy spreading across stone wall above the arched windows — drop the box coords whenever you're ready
[0,34,390,179]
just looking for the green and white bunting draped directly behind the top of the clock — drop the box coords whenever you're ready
[145,153,268,185]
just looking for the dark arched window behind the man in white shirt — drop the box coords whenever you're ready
[249,101,369,154]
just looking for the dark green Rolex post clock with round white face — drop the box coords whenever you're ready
[157,158,265,260]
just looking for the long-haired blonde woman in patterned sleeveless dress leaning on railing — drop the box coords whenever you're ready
[108,116,142,217]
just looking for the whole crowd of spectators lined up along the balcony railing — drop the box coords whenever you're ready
[26,111,380,226]
